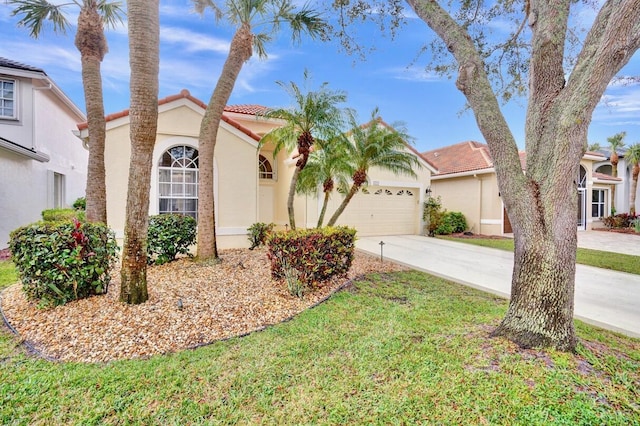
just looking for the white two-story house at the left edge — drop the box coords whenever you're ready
[0,57,89,248]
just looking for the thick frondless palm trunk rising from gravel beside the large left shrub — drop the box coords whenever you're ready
[120,0,160,304]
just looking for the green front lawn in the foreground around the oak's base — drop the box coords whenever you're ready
[0,262,640,425]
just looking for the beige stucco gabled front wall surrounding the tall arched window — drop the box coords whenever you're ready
[105,105,258,248]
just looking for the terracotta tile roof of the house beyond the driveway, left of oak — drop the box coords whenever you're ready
[422,141,493,175]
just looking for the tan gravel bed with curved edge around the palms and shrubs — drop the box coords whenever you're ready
[0,249,405,362]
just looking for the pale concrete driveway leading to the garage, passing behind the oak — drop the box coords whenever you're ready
[356,232,640,337]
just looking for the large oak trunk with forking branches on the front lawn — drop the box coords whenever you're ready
[407,0,640,350]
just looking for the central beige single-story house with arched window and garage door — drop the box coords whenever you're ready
[78,90,435,248]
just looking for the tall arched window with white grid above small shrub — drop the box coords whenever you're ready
[158,145,198,219]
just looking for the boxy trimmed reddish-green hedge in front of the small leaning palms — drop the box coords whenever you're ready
[267,226,356,285]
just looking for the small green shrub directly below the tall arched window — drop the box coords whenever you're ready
[147,214,196,265]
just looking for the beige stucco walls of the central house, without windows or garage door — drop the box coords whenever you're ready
[91,92,433,249]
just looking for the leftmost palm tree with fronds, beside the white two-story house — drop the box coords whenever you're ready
[8,0,124,223]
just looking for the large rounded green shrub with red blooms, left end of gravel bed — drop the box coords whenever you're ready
[9,219,118,306]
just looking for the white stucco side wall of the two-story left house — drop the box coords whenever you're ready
[0,79,88,248]
